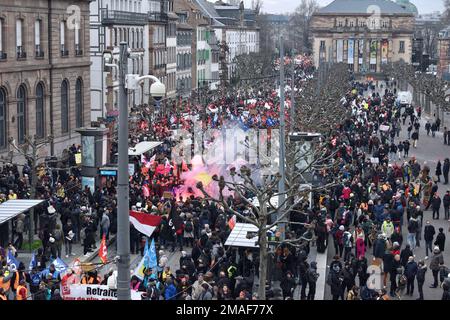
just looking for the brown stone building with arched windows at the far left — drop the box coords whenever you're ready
[0,0,90,155]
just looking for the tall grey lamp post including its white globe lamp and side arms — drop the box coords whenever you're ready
[103,42,166,300]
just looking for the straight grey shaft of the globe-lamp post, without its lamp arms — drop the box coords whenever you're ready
[117,42,131,300]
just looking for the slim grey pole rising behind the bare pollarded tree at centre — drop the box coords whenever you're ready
[278,36,286,241]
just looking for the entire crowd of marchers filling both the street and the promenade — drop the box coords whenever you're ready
[0,57,450,300]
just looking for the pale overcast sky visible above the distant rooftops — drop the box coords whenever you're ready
[255,0,444,13]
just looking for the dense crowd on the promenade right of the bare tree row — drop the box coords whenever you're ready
[316,82,450,300]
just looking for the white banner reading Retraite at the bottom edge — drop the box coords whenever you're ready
[61,284,142,300]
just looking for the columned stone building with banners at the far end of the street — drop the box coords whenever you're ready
[311,0,415,76]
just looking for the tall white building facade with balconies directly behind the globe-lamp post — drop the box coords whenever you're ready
[90,0,148,121]
